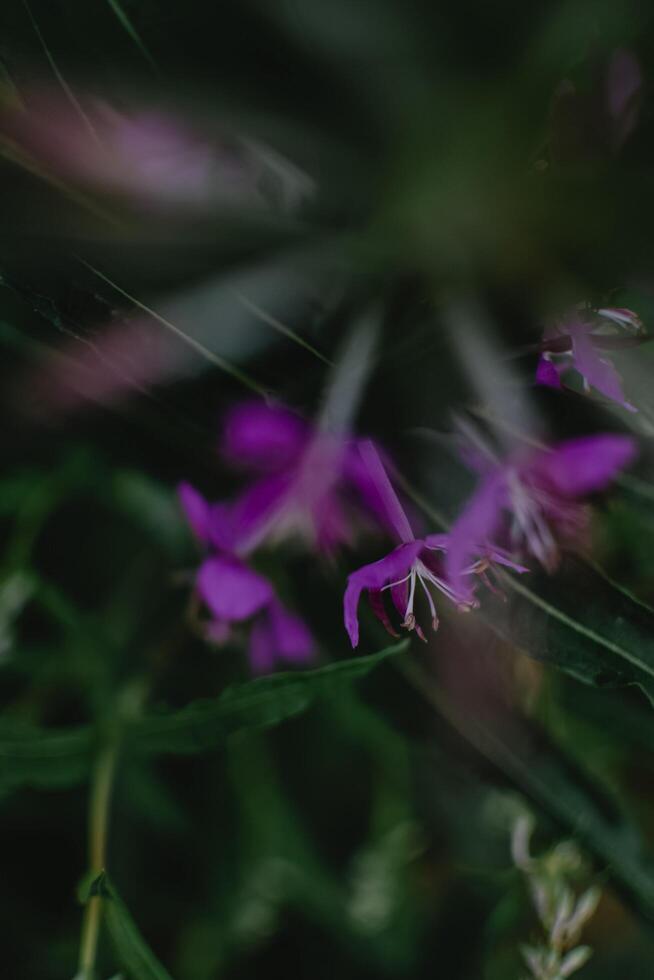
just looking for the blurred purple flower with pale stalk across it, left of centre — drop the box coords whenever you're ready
[222,402,392,555]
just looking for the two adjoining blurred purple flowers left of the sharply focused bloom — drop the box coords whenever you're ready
[179,403,386,673]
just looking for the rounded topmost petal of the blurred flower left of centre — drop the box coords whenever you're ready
[222,402,309,471]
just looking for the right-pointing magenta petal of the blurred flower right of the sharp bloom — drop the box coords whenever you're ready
[536,434,637,498]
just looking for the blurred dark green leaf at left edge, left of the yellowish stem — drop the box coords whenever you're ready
[0,724,95,792]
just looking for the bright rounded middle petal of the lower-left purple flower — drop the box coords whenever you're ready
[197,555,273,622]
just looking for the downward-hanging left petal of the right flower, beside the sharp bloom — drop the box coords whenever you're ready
[445,470,507,597]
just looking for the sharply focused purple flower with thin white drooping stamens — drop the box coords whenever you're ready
[343,442,526,647]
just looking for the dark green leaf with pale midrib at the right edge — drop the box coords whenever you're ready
[494,558,654,700]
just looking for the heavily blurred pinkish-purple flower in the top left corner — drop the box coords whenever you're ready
[0,89,313,209]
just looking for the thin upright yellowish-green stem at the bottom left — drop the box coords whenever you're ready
[76,738,118,980]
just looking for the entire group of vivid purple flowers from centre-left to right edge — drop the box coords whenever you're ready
[180,298,644,672]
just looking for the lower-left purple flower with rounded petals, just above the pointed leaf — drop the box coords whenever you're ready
[179,483,315,674]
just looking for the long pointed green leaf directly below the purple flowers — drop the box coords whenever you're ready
[131,640,407,753]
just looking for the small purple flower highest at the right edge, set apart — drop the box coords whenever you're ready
[536,307,644,412]
